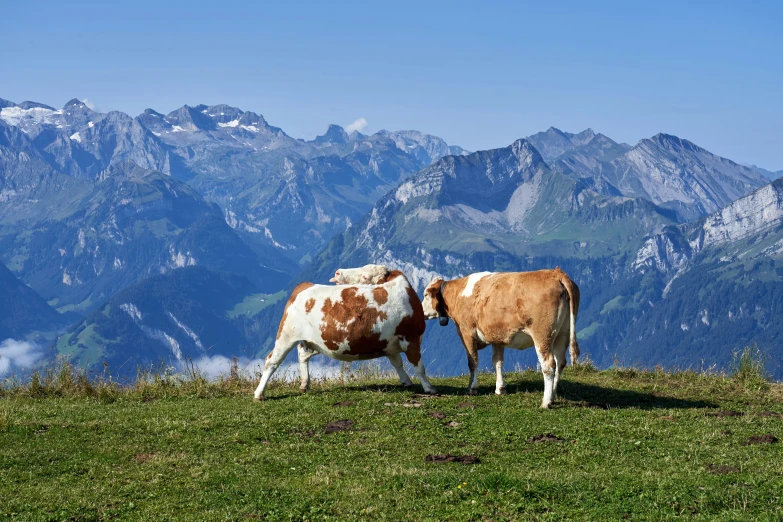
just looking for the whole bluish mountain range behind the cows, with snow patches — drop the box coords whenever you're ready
[0,95,783,373]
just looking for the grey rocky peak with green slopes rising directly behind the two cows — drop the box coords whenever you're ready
[316,140,675,287]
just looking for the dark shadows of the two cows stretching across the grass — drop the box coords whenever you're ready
[276,378,718,410]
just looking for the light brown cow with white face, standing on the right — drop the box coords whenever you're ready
[422,268,579,408]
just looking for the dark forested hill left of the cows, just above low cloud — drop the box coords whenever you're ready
[57,266,274,375]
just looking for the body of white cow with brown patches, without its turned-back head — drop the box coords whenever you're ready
[254,270,437,401]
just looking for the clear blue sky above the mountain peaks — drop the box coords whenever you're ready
[0,0,783,170]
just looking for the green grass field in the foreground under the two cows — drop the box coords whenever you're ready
[0,367,783,521]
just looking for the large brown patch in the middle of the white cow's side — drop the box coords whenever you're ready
[321,286,388,355]
